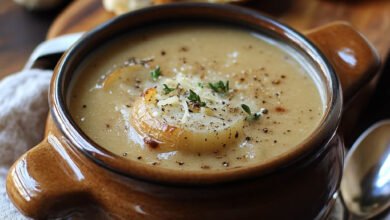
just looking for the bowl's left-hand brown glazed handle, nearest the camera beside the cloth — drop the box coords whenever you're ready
[6,132,89,219]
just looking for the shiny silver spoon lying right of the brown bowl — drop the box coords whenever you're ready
[340,120,390,219]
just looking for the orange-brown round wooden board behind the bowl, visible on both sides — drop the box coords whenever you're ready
[47,0,390,61]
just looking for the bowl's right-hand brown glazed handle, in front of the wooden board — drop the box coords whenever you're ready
[306,22,380,102]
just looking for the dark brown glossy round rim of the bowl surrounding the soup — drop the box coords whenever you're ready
[49,3,342,185]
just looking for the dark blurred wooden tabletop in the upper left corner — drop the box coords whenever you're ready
[0,0,61,79]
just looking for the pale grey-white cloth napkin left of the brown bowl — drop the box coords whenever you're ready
[0,70,52,219]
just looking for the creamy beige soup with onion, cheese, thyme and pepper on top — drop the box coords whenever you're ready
[67,24,325,171]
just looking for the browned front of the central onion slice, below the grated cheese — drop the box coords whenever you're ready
[130,96,244,152]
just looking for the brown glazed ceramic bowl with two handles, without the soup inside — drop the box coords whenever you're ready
[7,4,379,219]
